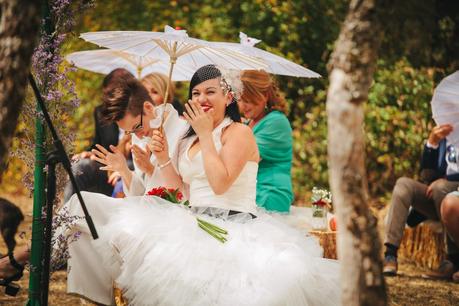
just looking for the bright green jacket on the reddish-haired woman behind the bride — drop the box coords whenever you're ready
[253,111,293,212]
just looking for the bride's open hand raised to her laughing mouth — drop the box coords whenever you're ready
[183,100,214,137]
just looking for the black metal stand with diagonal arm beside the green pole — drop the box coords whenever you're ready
[29,74,99,306]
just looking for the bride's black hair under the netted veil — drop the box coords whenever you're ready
[183,65,241,138]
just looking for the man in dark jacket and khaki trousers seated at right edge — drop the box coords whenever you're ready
[383,125,459,279]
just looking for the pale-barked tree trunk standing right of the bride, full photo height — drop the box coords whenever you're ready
[327,0,391,306]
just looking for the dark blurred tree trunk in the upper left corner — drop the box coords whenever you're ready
[0,0,41,177]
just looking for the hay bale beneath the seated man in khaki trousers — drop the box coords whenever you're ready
[398,221,446,269]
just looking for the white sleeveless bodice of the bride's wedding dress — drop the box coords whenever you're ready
[178,118,258,213]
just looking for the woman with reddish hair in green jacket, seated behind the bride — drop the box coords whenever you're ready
[238,70,293,212]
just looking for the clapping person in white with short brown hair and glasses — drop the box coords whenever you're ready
[93,68,187,195]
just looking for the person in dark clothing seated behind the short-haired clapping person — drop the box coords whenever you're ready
[64,69,133,202]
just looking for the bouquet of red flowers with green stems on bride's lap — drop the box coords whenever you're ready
[147,187,228,243]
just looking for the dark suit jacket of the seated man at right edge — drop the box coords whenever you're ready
[421,139,459,183]
